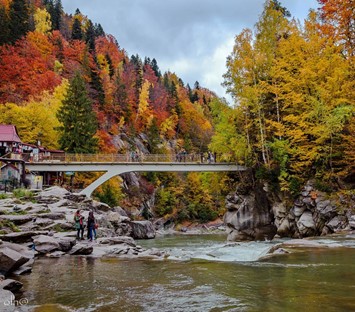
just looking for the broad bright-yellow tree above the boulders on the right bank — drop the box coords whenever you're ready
[272,13,352,188]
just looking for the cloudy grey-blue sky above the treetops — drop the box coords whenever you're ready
[62,0,318,100]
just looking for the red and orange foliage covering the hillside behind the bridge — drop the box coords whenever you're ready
[0,0,217,157]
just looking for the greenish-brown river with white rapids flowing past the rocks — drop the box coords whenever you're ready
[20,235,355,312]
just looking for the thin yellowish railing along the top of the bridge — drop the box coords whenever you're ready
[34,153,211,163]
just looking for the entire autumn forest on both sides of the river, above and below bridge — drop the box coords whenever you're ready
[0,0,355,222]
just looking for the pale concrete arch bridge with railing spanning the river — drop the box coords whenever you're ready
[25,154,246,197]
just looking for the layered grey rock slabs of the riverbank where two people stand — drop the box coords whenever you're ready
[0,187,355,310]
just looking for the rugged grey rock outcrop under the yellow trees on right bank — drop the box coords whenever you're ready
[224,181,355,241]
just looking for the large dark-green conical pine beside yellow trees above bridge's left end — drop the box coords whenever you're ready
[57,72,98,154]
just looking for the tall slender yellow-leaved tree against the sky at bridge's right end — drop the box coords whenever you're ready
[224,0,289,167]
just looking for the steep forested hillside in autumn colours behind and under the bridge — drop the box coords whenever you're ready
[0,0,228,223]
